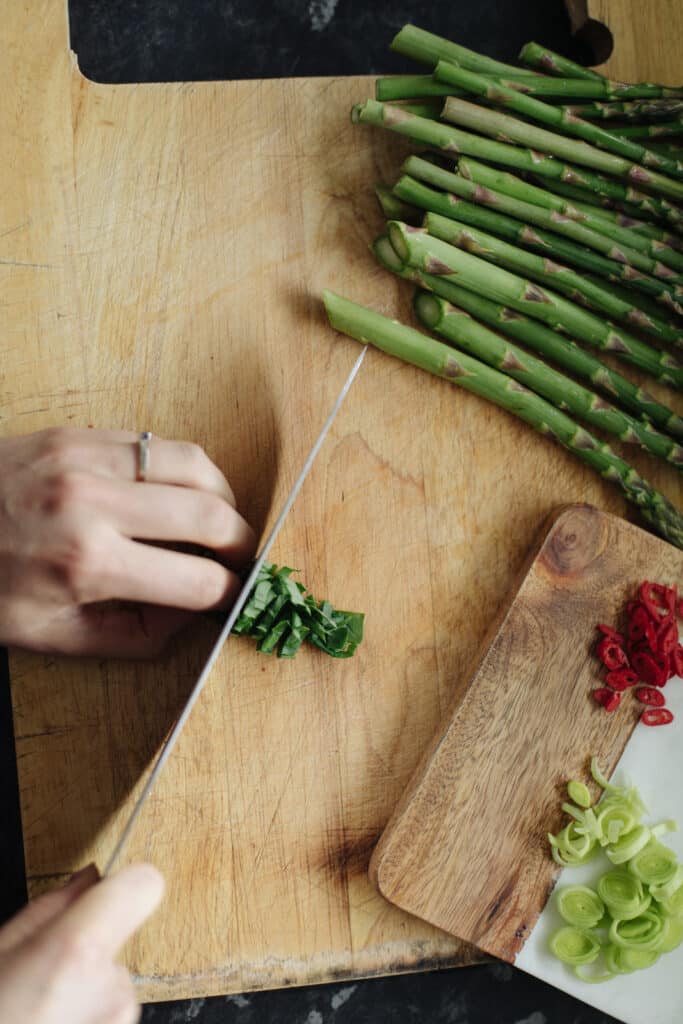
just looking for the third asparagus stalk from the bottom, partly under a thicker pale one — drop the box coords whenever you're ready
[372,234,683,440]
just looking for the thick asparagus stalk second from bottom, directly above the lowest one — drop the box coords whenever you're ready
[414,291,683,469]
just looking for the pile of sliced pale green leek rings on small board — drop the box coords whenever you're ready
[548,759,683,982]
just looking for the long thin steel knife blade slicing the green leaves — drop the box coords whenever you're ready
[102,345,368,878]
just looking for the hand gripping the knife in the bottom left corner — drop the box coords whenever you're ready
[0,864,164,1024]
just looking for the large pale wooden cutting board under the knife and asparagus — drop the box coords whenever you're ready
[0,0,682,999]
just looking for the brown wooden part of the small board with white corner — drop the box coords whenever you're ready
[370,505,683,963]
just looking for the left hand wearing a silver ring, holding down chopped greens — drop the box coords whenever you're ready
[0,428,255,657]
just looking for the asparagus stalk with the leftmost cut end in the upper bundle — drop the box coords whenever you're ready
[351,99,683,227]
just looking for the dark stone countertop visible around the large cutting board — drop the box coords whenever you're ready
[0,0,616,1024]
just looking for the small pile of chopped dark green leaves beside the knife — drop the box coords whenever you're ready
[232,562,365,657]
